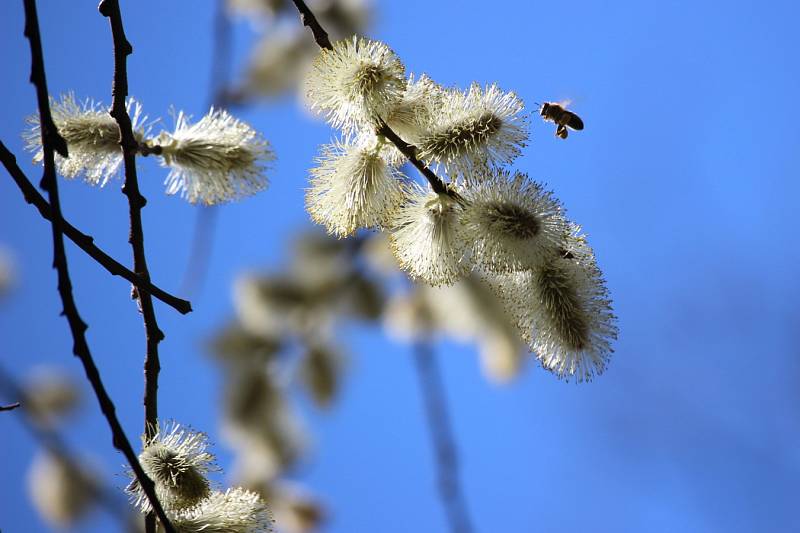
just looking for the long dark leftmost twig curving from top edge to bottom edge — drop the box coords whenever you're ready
[24,0,175,533]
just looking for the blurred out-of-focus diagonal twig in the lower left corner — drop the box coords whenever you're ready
[0,367,129,525]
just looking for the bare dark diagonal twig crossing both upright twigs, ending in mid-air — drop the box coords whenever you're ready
[0,141,192,315]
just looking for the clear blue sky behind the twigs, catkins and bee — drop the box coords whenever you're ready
[0,0,800,533]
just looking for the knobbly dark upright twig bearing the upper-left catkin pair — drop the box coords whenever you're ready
[99,0,164,532]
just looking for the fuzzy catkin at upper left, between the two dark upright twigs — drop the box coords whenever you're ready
[23,93,148,187]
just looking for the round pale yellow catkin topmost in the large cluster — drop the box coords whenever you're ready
[306,36,406,133]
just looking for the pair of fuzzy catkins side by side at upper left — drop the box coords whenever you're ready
[24,93,275,205]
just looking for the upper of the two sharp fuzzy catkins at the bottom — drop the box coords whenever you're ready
[127,423,217,513]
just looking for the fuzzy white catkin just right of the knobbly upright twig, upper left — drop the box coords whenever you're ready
[153,108,275,205]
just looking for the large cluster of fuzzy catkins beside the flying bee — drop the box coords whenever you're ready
[306,37,617,381]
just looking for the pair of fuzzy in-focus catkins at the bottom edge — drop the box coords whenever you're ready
[126,423,274,533]
